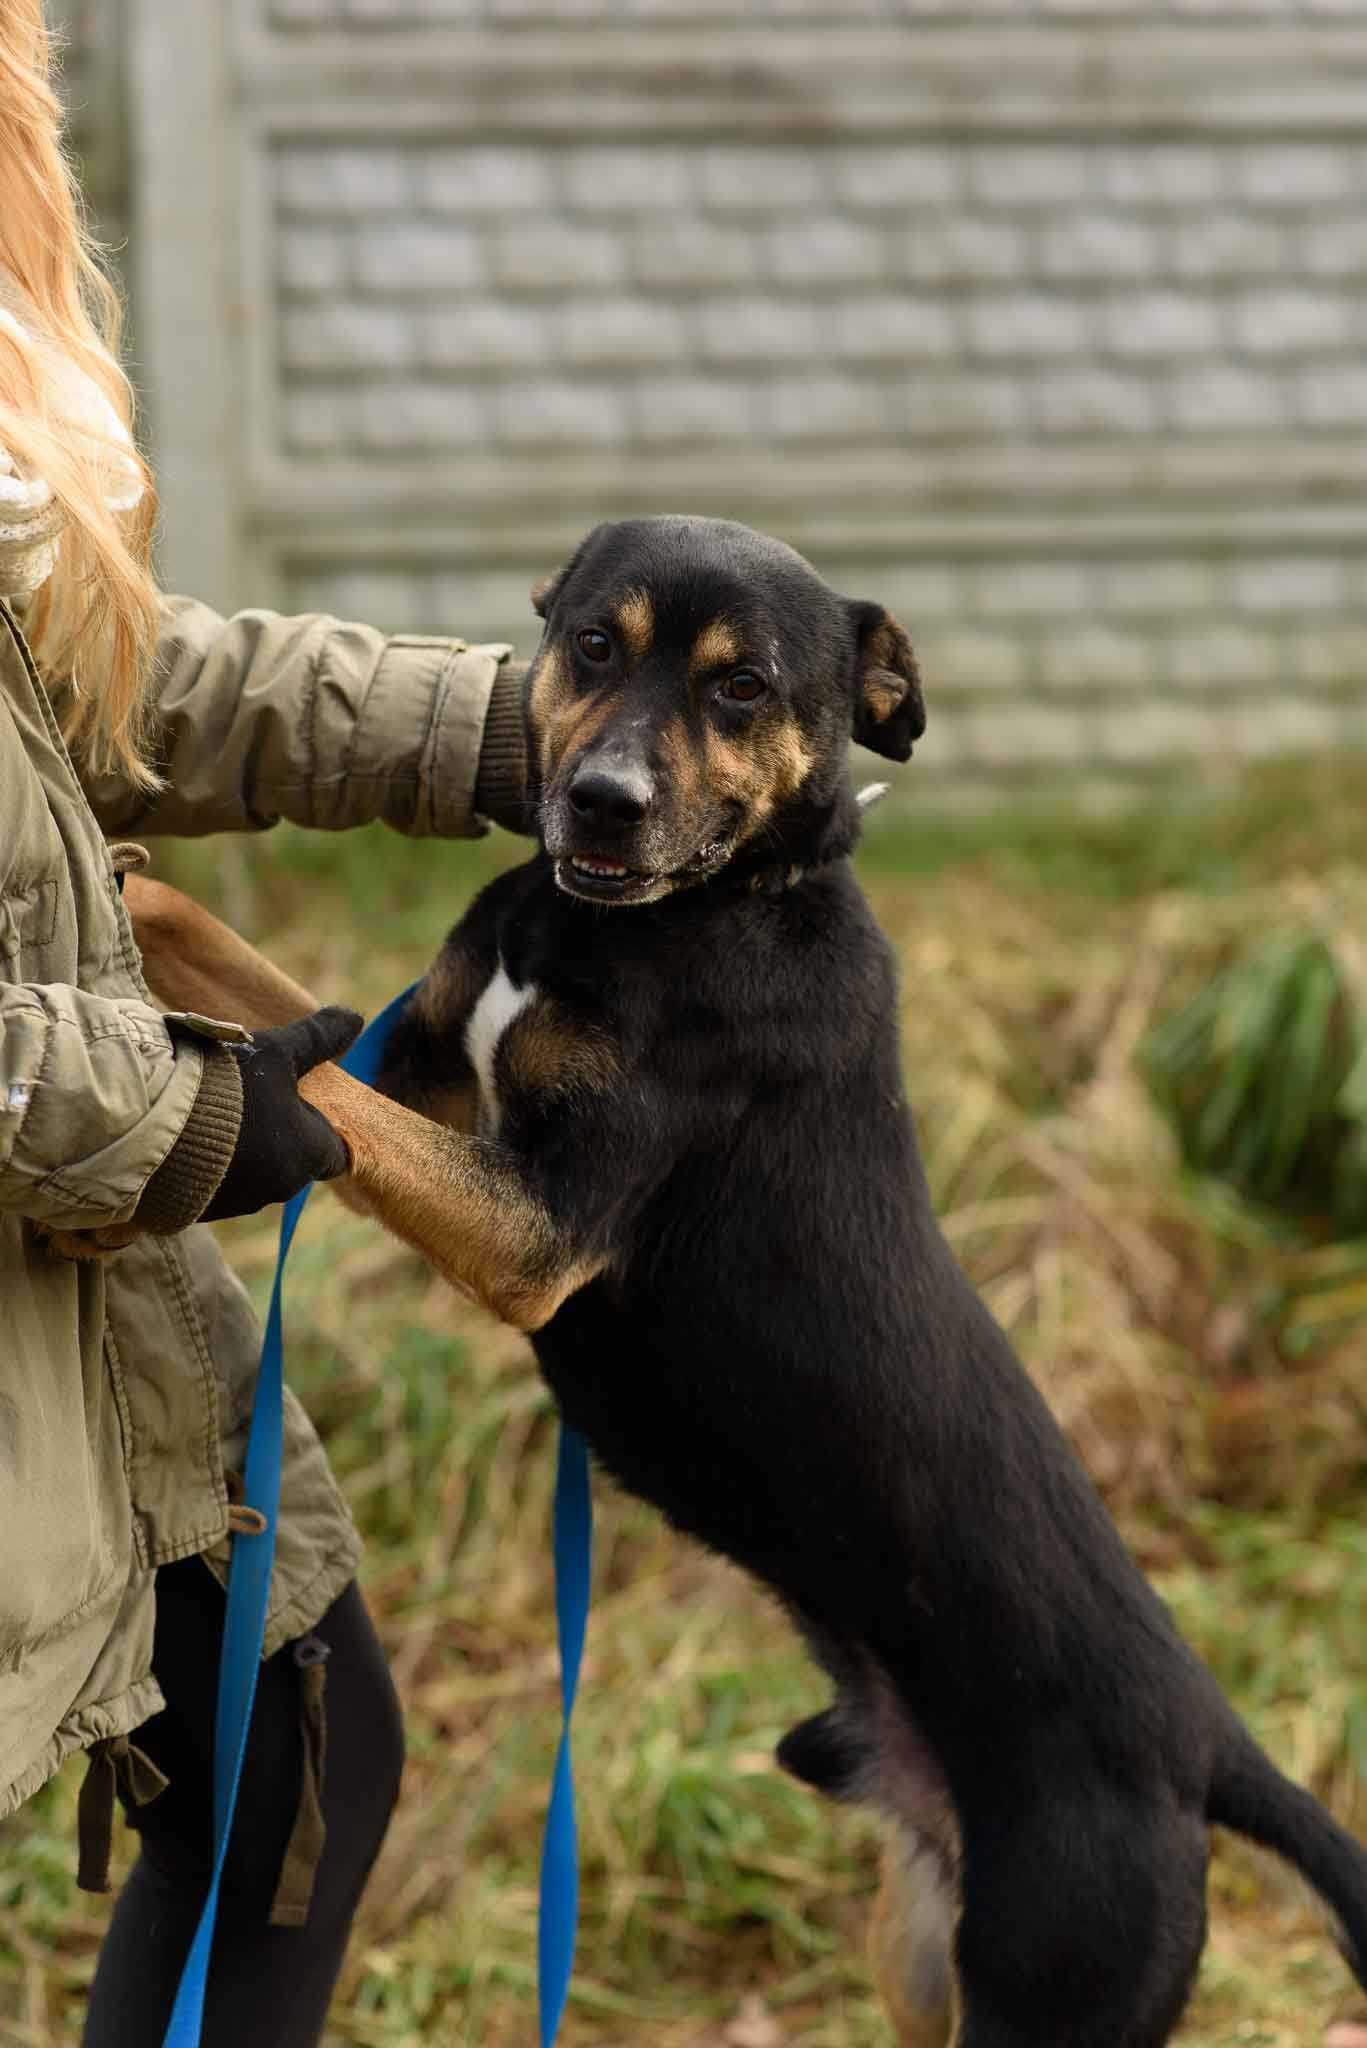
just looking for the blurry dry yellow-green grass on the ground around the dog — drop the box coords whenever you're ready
[0,768,1367,2048]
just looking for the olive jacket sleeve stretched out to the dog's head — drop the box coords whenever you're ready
[88,598,525,838]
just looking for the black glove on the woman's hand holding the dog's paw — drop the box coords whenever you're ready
[201,1006,363,1223]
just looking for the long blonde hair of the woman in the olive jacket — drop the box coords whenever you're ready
[0,0,158,788]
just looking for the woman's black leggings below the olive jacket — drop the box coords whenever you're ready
[84,1559,404,2048]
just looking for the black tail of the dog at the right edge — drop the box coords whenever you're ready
[1205,1722,1367,1989]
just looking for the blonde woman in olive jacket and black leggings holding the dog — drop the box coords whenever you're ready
[0,0,523,2048]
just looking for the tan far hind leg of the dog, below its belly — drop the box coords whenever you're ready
[869,1827,959,2048]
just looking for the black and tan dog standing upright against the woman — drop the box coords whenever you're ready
[129,518,1367,2048]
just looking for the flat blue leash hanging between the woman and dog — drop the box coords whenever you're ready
[162,983,592,2048]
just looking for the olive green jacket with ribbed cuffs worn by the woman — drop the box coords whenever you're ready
[0,600,521,1817]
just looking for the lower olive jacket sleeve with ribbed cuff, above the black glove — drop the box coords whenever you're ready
[0,983,242,1233]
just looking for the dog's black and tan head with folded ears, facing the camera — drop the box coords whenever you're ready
[527,518,924,903]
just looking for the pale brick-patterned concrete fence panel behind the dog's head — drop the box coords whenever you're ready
[83,0,1367,793]
